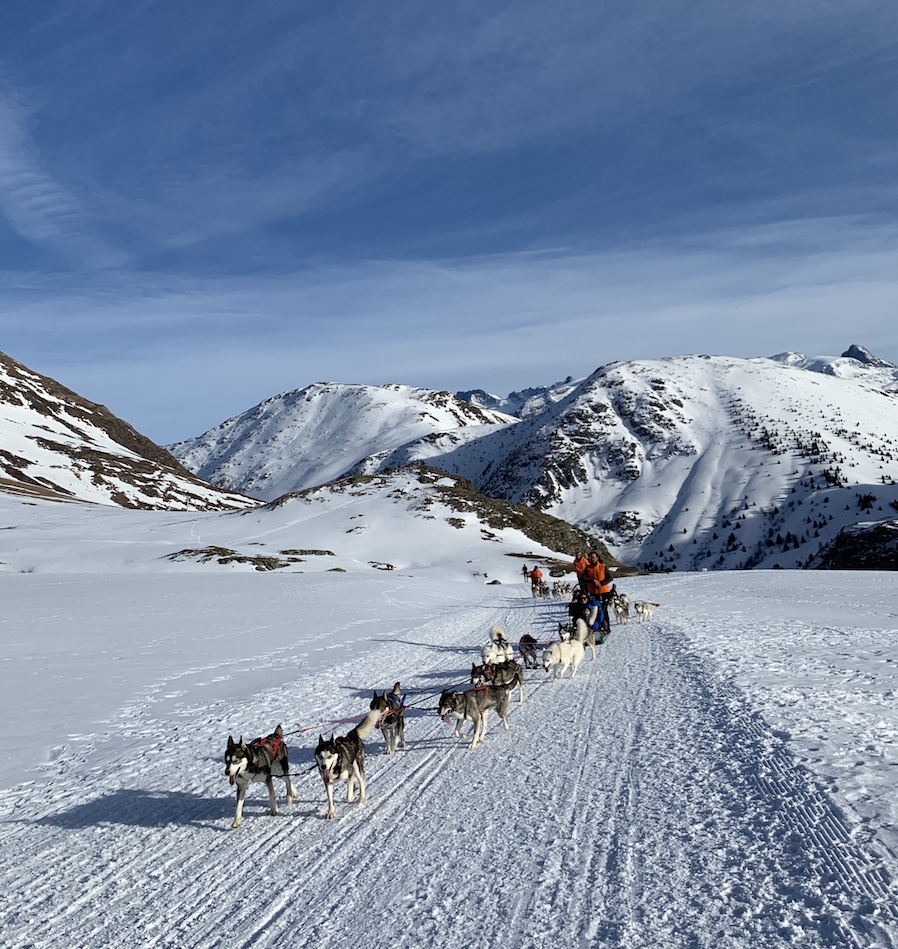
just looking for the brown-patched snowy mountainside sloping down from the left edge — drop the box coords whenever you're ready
[0,353,255,510]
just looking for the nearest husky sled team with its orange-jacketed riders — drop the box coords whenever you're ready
[224,551,660,829]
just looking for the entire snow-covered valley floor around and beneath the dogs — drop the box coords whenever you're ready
[0,486,898,949]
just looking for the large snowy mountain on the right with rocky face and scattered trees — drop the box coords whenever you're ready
[350,356,898,569]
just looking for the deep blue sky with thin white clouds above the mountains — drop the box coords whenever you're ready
[0,0,898,443]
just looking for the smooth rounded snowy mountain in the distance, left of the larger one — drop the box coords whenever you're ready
[169,383,514,501]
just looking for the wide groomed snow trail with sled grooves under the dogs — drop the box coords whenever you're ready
[0,597,898,949]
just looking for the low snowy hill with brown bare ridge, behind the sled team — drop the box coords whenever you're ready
[0,468,590,583]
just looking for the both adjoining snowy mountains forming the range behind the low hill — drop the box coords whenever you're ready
[171,346,898,569]
